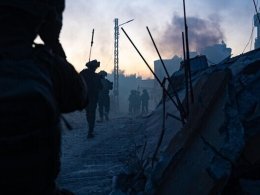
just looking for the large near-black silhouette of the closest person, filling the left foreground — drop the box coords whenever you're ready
[0,0,87,195]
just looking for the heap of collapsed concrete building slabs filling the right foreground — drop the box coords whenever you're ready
[111,49,260,195]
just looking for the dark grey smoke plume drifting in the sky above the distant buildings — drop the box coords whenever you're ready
[160,15,224,55]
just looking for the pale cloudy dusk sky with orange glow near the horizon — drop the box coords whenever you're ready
[60,0,258,77]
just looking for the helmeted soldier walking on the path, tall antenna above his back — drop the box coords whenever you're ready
[80,60,102,138]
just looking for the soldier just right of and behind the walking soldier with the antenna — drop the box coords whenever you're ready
[98,70,113,122]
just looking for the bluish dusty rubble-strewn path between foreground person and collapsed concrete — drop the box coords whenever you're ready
[58,111,143,195]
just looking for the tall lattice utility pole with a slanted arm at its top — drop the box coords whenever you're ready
[113,18,134,112]
